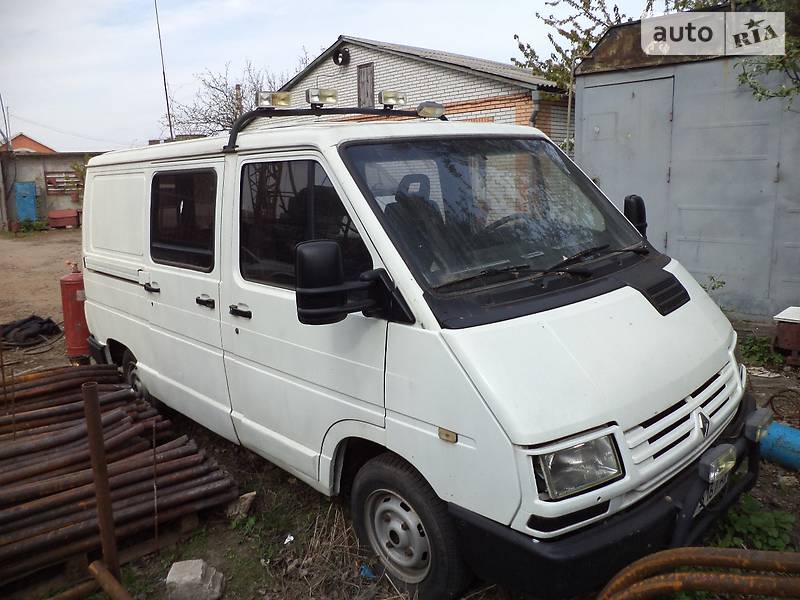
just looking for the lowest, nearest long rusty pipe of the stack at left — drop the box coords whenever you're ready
[0,487,239,583]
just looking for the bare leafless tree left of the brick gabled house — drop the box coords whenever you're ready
[164,46,311,135]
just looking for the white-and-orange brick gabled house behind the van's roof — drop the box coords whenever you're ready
[272,36,567,143]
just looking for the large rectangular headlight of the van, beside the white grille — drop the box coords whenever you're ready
[534,435,622,500]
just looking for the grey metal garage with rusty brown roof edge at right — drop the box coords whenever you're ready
[575,12,800,318]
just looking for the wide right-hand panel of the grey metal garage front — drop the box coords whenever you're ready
[668,60,783,315]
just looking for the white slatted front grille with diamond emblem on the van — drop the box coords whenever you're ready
[625,362,736,465]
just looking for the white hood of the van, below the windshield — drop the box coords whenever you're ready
[442,260,735,445]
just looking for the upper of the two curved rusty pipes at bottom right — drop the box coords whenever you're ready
[597,548,800,600]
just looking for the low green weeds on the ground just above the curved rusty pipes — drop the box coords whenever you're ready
[713,495,795,550]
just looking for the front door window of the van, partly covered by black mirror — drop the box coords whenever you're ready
[239,160,372,288]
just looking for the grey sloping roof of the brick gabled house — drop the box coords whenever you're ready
[281,35,558,91]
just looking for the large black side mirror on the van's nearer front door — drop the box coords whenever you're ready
[295,240,375,325]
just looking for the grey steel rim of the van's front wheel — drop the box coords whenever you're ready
[364,489,431,583]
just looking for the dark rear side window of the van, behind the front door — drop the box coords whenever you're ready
[150,170,217,272]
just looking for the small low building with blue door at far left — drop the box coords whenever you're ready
[0,133,101,229]
